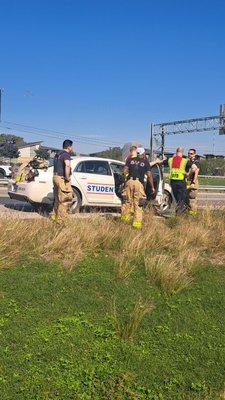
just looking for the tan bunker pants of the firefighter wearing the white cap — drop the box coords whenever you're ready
[121,178,146,226]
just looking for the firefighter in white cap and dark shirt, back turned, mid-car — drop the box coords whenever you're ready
[121,147,155,228]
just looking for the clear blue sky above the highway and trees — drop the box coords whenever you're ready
[0,0,225,153]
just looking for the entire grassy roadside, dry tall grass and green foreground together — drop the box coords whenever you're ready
[0,212,225,400]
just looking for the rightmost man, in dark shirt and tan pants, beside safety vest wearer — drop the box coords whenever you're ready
[186,149,200,216]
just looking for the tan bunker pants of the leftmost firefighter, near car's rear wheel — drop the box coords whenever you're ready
[52,175,73,222]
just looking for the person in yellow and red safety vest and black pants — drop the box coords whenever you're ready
[168,147,188,215]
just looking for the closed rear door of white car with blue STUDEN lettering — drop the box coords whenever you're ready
[74,159,115,205]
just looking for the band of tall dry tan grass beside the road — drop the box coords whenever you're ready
[0,210,225,293]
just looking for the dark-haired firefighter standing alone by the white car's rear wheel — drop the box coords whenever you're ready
[51,139,73,223]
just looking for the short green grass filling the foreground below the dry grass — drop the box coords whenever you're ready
[0,254,225,400]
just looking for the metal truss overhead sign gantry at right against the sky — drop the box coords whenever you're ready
[150,104,225,158]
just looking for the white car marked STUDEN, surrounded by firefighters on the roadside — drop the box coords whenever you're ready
[8,156,172,213]
